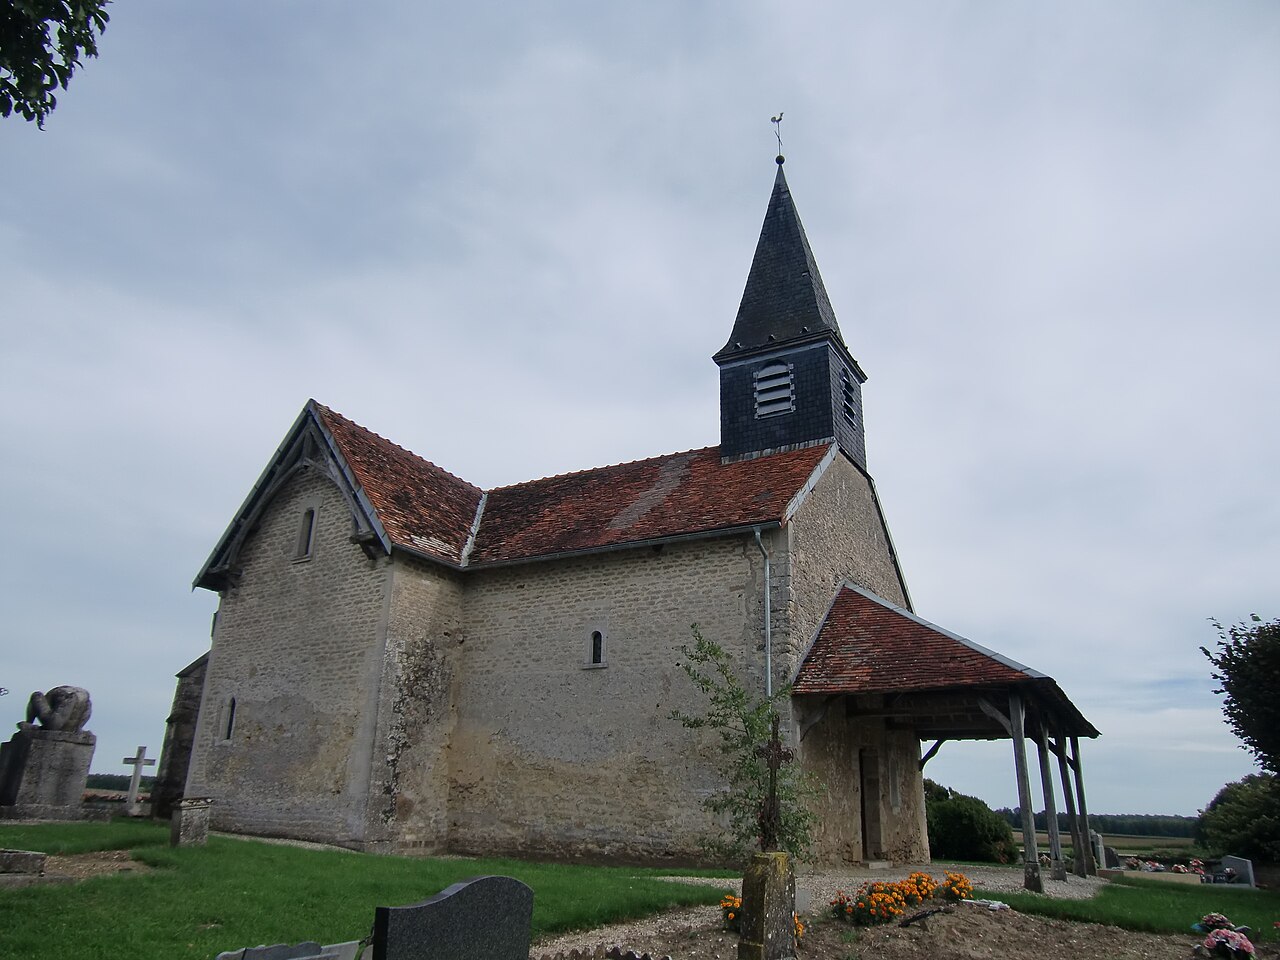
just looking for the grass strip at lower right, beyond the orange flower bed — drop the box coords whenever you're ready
[974,877,1280,943]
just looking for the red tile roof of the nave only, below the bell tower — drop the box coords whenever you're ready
[470,444,829,566]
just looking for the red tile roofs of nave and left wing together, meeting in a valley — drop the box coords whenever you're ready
[312,402,831,566]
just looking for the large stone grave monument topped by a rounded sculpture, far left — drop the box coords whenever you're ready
[0,686,97,820]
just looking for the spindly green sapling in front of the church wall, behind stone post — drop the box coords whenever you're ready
[671,623,814,860]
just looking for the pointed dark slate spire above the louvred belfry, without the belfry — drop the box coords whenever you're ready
[714,156,844,362]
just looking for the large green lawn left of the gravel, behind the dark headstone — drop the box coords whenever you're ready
[0,820,728,960]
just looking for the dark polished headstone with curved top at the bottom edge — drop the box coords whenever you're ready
[374,877,534,960]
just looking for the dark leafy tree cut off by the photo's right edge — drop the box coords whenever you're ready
[1201,614,1280,773]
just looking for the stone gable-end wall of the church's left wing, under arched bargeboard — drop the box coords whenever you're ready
[186,470,390,844]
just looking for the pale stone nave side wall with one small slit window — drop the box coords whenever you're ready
[449,538,763,860]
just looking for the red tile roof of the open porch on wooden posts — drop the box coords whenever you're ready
[792,584,1044,694]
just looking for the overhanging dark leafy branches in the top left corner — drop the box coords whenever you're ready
[0,0,110,127]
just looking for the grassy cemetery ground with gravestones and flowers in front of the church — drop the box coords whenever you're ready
[0,680,1280,960]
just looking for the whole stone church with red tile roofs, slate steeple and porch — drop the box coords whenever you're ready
[173,157,1096,864]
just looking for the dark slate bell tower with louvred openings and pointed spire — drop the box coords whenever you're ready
[713,156,867,470]
